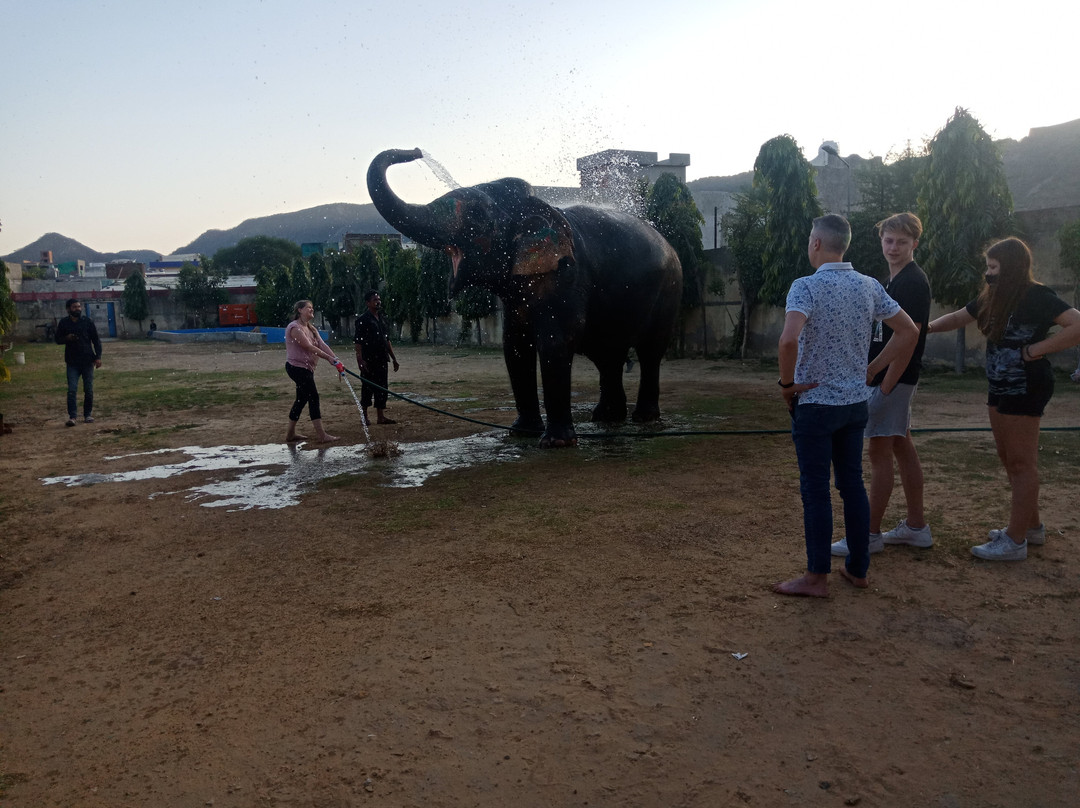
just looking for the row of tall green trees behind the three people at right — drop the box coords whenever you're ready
[720,107,1080,369]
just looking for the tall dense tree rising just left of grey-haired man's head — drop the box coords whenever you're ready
[754,135,821,306]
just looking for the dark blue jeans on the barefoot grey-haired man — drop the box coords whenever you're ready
[792,402,870,578]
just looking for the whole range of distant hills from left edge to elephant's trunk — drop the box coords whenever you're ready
[3,202,396,264]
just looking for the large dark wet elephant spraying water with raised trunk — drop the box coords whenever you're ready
[367,149,683,447]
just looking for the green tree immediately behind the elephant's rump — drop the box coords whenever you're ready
[645,173,711,355]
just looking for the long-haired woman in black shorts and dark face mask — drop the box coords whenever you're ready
[927,239,1080,561]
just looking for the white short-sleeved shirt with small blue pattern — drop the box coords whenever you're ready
[787,261,900,406]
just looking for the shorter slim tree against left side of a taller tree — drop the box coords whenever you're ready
[720,186,769,358]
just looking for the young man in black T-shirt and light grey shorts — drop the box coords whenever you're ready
[833,213,934,555]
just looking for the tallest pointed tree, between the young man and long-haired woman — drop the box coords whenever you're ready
[917,107,1013,373]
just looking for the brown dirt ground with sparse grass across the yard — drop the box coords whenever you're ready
[0,341,1080,808]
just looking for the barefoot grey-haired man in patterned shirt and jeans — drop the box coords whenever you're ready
[772,214,919,597]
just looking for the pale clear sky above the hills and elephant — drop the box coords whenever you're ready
[0,0,1080,255]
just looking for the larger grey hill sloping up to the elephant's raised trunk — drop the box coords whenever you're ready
[174,202,397,255]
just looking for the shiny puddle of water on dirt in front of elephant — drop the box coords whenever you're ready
[41,432,532,511]
